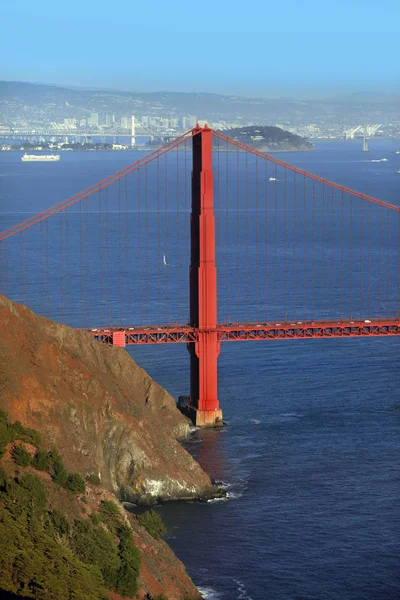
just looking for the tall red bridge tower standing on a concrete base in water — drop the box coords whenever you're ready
[188,127,222,427]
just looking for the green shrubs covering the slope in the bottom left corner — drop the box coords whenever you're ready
[0,413,140,600]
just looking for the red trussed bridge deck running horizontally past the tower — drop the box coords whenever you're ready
[85,317,400,347]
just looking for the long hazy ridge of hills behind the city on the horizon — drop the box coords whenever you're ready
[0,81,400,125]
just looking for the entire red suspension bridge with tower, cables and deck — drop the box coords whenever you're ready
[0,126,400,426]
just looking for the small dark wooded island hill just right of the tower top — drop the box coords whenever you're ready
[223,125,314,152]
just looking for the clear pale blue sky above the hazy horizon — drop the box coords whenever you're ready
[0,0,400,95]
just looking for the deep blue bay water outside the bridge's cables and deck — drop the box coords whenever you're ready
[0,141,400,600]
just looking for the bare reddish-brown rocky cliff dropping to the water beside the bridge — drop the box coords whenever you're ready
[0,295,215,504]
